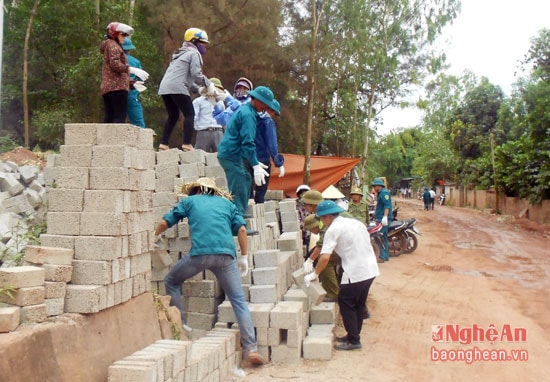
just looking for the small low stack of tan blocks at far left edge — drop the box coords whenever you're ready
[0,266,47,333]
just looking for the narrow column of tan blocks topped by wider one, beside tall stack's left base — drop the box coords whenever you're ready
[24,245,74,317]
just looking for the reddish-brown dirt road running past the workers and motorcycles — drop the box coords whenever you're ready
[245,199,550,382]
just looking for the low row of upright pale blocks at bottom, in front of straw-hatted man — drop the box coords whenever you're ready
[108,329,242,382]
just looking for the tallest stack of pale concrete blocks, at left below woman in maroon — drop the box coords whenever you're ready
[40,124,155,313]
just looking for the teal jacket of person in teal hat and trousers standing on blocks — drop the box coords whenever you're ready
[218,102,259,166]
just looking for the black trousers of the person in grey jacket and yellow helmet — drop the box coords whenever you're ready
[160,94,195,145]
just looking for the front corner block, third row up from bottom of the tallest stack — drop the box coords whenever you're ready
[74,236,123,260]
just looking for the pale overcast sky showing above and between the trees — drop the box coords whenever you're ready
[378,0,550,134]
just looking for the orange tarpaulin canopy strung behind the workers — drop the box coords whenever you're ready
[269,154,361,197]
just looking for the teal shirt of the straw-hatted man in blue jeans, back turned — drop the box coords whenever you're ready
[163,194,246,257]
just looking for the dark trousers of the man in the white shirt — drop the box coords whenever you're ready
[338,277,375,344]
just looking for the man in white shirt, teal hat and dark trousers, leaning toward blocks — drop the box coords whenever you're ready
[304,200,380,350]
